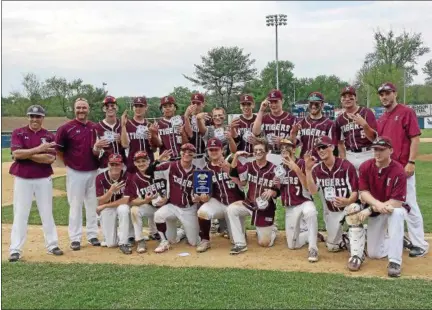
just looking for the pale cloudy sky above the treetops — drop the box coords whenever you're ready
[2,1,432,97]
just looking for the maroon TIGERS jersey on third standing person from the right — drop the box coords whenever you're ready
[297,116,337,159]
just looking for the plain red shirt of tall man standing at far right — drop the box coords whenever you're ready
[378,103,421,167]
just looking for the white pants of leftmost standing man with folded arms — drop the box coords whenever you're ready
[9,177,58,254]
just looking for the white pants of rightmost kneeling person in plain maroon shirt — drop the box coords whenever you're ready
[366,208,407,265]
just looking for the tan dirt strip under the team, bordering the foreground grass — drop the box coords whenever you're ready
[2,224,432,279]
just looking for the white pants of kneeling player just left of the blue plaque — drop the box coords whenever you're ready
[154,203,199,246]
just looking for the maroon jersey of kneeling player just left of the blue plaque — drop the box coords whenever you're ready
[154,160,197,208]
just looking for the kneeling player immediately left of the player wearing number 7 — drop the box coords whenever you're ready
[227,139,279,255]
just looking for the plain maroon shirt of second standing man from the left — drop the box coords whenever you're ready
[55,119,99,171]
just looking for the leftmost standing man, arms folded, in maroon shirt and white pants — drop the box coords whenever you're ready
[9,105,63,262]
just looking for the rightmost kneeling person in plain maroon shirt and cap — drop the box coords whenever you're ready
[359,137,409,277]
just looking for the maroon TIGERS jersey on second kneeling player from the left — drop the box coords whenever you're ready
[125,171,168,201]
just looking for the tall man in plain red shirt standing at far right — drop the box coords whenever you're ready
[377,83,429,257]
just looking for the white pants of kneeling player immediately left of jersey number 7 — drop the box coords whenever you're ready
[227,201,277,247]
